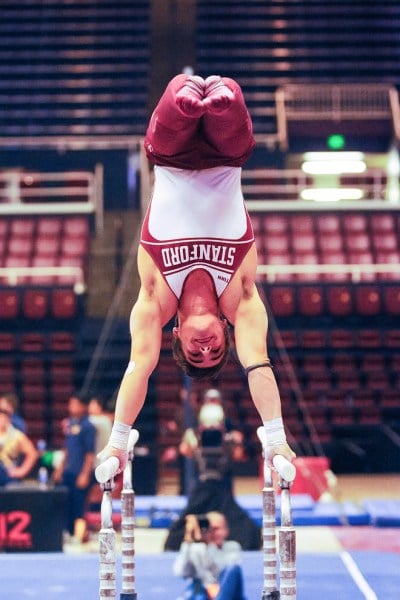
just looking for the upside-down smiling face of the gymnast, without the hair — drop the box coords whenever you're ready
[173,314,226,368]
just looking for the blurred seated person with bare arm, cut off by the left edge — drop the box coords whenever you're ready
[0,394,38,485]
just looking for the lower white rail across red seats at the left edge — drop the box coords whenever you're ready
[0,266,85,294]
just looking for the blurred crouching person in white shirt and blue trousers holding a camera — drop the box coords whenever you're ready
[174,512,245,600]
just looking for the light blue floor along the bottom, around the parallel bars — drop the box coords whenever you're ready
[0,551,400,600]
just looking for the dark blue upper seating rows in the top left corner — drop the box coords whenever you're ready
[0,0,149,141]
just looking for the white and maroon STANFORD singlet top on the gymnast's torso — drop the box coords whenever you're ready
[141,166,254,298]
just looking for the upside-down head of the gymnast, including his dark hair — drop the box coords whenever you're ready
[172,314,230,379]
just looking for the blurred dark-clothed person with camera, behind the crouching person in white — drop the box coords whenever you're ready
[165,390,261,551]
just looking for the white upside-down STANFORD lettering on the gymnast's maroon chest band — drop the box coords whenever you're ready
[161,243,236,269]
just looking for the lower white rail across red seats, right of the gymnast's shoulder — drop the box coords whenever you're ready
[257,263,400,283]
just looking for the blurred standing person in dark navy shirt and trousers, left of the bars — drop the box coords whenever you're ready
[53,395,96,542]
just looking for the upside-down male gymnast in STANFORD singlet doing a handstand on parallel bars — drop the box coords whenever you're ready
[100,74,295,471]
